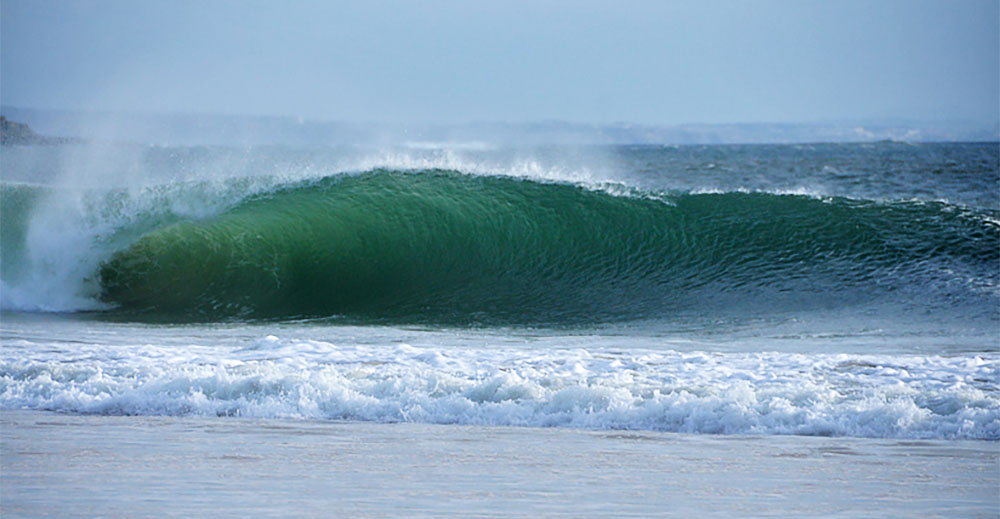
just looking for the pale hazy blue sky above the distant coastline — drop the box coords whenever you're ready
[0,0,1000,124]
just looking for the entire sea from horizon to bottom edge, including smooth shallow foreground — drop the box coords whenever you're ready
[0,141,1000,517]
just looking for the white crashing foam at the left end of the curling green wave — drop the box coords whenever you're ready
[0,177,292,312]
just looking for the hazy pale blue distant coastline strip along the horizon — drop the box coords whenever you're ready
[0,106,1000,147]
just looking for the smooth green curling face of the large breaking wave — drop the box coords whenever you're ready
[99,171,1000,323]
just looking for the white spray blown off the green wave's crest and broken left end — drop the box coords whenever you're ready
[0,142,620,312]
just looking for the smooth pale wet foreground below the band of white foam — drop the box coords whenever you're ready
[0,410,1000,518]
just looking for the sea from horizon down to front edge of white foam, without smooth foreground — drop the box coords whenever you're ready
[0,142,1000,516]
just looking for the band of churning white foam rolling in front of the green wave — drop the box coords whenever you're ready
[0,335,1000,440]
